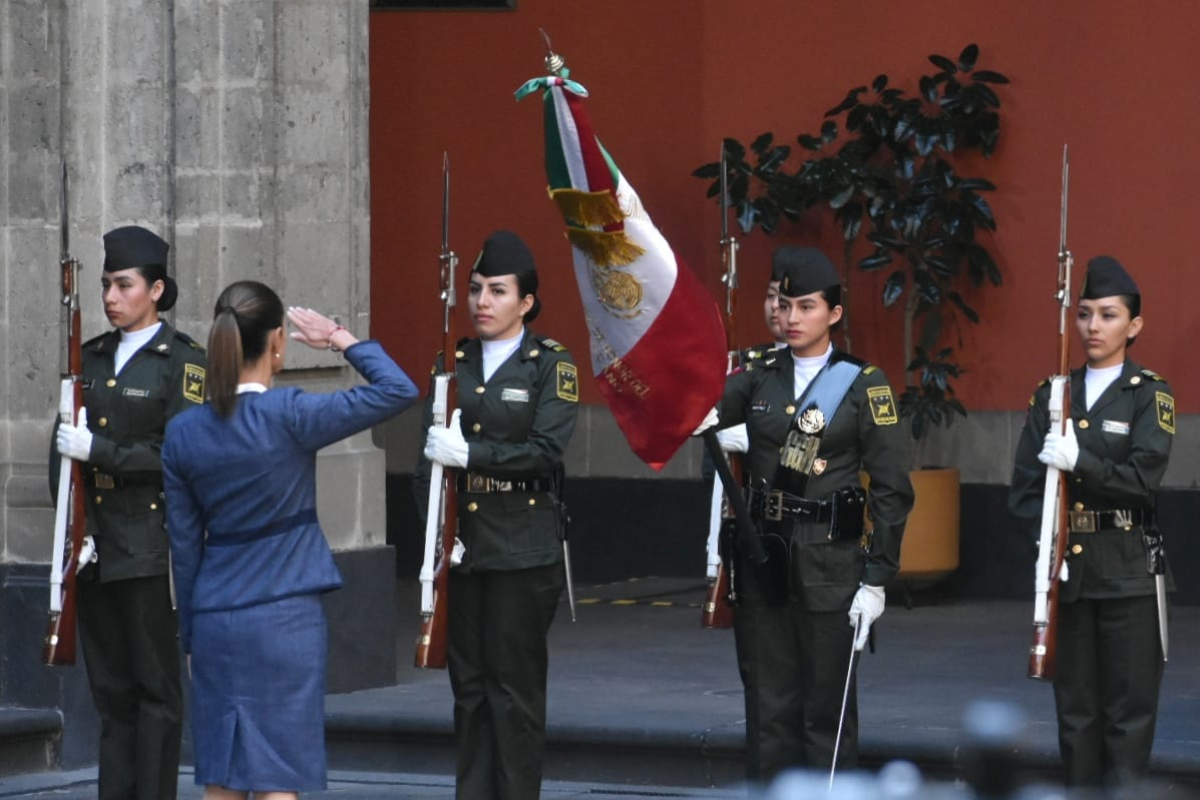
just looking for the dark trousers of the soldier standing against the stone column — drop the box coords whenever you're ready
[77,575,184,800]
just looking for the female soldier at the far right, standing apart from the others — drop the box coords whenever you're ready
[1009,255,1175,786]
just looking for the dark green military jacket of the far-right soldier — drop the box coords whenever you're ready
[1009,359,1175,602]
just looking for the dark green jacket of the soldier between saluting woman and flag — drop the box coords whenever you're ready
[415,329,580,572]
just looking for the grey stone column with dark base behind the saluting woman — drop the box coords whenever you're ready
[0,0,384,763]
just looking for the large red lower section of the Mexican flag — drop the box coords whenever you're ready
[596,251,726,470]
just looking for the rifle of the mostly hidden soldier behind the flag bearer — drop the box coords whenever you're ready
[700,142,742,627]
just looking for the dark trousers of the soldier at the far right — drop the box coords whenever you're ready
[1054,595,1163,786]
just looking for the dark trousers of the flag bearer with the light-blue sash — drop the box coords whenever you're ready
[733,593,858,782]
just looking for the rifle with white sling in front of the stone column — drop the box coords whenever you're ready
[42,162,95,666]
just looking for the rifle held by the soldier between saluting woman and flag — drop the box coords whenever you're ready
[414,154,458,669]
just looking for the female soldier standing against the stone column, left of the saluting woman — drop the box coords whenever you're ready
[55,225,205,800]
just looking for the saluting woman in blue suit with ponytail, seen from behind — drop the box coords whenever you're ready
[162,281,418,800]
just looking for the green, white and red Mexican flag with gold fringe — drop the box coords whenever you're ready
[516,71,727,469]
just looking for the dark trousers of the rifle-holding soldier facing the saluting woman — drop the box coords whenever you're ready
[446,564,566,800]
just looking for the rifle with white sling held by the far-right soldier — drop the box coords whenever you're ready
[1028,145,1074,680]
